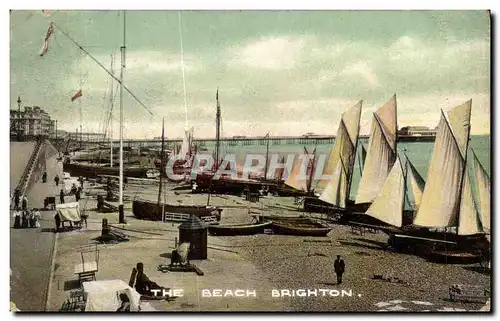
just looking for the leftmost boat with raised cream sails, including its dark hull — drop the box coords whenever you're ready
[304,101,363,212]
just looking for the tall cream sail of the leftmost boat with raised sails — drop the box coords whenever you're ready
[316,100,363,190]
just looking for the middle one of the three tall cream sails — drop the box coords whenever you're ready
[356,95,397,204]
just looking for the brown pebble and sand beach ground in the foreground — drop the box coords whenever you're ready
[47,179,491,312]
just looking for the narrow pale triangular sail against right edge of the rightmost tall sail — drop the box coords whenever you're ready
[458,170,483,235]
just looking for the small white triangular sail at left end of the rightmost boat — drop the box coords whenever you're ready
[366,157,405,227]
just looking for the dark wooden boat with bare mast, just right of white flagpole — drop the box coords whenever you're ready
[132,119,222,224]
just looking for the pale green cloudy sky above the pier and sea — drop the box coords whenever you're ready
[10,10,491,138]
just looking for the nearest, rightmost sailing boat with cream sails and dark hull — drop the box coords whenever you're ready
[366,100,488,257]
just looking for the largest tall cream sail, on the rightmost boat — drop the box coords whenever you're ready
[413,101,471,227]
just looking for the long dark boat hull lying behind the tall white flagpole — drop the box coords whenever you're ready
[63,163,150,178]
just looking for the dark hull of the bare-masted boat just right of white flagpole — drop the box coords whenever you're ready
[132,200,222,221]
